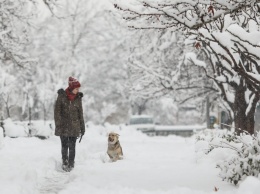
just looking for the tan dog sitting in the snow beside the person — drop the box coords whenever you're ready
[107,132,123,162]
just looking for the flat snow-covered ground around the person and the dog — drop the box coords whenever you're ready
[0,123,260,194]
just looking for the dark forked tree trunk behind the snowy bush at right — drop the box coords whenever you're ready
[233,84,259,135]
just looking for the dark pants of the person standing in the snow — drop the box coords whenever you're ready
[60,136,77,167]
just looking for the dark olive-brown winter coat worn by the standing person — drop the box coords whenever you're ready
[54,89,85,137]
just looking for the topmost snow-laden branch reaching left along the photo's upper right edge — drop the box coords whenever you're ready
[114,0,260,31]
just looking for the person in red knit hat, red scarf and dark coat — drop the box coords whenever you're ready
[54,77,85,171]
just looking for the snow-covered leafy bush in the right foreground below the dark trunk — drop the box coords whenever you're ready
[197,131,260,185]
